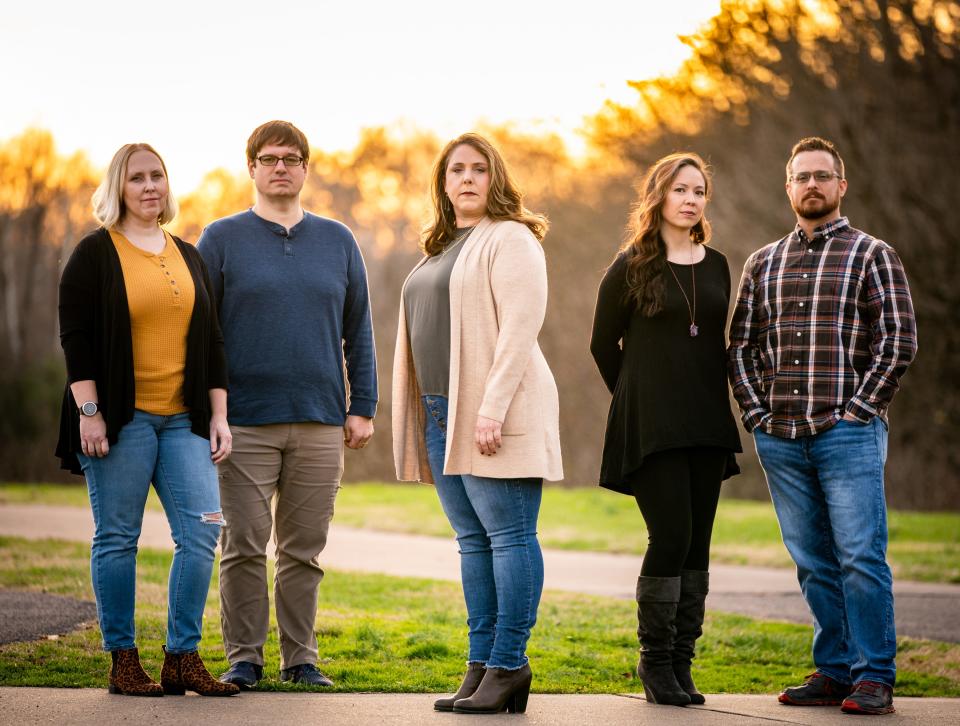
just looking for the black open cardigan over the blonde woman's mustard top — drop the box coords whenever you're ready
[56,227,227,474]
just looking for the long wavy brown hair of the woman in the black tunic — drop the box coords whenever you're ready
[620,152,711,317]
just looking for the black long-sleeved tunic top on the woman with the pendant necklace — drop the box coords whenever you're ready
[590,247,742,494]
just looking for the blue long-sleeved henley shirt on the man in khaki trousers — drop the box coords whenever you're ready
[197,210,377,426]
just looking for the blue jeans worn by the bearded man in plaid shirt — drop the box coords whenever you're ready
[754,418,897,687]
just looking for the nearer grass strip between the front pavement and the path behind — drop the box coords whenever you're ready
[0,538,960,696]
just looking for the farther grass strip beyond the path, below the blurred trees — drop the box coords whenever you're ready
[0,483,960,582]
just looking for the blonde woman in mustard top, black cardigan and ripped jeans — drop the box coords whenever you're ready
[57,144,239,696]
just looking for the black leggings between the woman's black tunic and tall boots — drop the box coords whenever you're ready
[630,447,728,577]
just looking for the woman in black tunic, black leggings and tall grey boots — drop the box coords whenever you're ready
[590,153,741,706]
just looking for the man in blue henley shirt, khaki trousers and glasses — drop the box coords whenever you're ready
[198,121,377,688]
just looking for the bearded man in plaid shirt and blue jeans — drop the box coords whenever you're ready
[728,137,917,714]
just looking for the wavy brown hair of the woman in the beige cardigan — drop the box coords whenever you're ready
[420,133,550,257]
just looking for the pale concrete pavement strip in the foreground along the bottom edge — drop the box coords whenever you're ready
[0,688,960,726]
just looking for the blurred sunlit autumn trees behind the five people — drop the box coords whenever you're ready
[0,0,960,509]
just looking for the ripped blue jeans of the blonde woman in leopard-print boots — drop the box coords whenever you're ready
[79,410,223,653]
